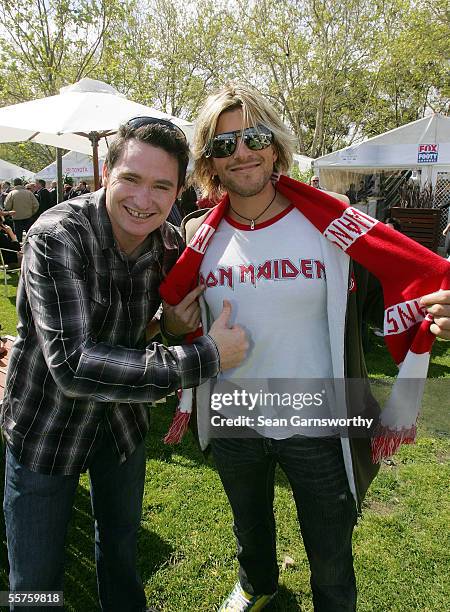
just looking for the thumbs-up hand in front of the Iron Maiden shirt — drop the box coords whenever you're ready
[209,300,249,370]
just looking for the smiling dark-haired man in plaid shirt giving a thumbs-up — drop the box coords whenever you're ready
[1,117,247,612]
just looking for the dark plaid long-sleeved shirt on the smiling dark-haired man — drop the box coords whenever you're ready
[1,190,219,474]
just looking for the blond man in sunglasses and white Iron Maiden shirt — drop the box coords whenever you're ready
[169,84,450,612]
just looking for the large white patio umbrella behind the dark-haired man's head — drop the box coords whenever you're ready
[0,78,192,188]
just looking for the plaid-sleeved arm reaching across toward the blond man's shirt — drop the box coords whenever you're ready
[22,234,219,402]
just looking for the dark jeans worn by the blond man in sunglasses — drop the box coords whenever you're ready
[211,437,356,612]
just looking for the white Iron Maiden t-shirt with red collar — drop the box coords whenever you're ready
[200,206,333,437]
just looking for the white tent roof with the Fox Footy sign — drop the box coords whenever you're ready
[313,113,450,190]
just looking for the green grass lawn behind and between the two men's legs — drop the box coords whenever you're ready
[0,274,450,612]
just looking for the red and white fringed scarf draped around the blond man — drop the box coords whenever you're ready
[160,176,450,462]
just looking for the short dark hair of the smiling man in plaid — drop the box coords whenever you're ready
[105,123,189,188]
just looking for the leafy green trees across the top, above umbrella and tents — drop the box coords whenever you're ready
[0,0,449,169]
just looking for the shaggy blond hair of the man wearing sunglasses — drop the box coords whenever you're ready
[192,83,296,201]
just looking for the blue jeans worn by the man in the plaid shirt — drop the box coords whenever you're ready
[4,432,146,612]
